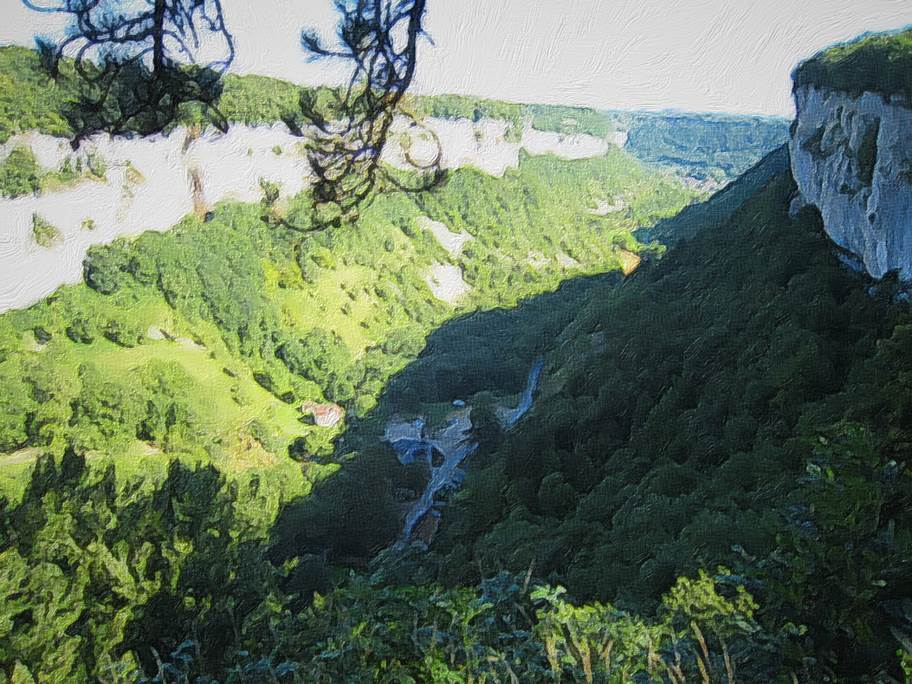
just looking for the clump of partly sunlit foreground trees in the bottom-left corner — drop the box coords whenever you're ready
[0,451,280,682]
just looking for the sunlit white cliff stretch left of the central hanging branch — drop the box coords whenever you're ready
[0,126,309,311]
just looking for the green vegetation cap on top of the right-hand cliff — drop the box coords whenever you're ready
[794,29,912,100]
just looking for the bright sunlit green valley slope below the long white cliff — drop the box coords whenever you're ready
[0,150,691,502]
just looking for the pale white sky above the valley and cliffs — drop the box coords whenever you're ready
[0,0,912,116]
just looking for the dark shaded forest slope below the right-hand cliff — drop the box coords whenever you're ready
[380,171,912,678]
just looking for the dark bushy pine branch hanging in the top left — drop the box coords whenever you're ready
[23,0,234,144]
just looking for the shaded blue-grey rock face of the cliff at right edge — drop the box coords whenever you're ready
[789,88,912,279]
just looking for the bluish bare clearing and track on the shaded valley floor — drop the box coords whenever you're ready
[384,358,544,541]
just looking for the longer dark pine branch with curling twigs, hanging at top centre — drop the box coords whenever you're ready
[301,0,441,224]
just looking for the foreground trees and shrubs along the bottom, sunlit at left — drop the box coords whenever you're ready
[0,451,774,682]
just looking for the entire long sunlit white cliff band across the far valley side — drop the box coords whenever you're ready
[0,119,608,312]
